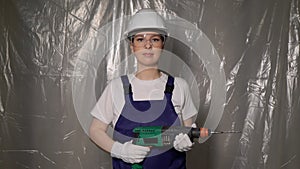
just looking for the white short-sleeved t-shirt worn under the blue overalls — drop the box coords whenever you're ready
[91,73,197,126]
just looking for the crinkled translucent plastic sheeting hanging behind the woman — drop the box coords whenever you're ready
[0,0,300,169]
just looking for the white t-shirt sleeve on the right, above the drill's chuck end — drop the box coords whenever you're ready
[176,78,198,120]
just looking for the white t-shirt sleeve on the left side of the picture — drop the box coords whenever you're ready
[91,83,113,124]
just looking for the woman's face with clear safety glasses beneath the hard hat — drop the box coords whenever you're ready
[130,32,164,67]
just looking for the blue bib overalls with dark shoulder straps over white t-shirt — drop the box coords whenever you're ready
[113,75,186,169]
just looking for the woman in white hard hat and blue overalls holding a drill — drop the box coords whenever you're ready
[90,9,197,169]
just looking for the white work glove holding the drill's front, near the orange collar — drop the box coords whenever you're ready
[173,123,196,152]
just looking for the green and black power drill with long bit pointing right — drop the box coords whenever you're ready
[133,126,240,147]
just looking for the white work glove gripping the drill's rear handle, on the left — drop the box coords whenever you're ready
[110,141,150,164]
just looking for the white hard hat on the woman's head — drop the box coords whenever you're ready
[125,8,167,37]
